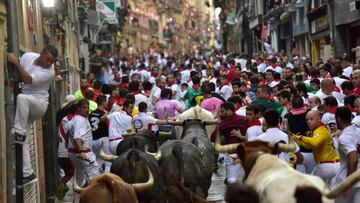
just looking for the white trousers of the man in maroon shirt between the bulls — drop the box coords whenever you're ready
[224,155,245,183]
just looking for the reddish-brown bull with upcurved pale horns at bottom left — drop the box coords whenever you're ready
[74,169,154,203]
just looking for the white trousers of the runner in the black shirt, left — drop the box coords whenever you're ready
[92,137,111,173]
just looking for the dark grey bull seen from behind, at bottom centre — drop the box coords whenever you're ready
[159,140,208,203]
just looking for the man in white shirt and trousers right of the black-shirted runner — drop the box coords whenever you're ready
[105,100,134,154]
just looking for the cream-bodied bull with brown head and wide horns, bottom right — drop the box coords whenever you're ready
[215,137,360,203]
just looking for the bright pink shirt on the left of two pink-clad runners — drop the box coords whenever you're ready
[155,99,181,119]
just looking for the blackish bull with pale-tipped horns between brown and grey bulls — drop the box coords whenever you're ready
[100,147,165,203]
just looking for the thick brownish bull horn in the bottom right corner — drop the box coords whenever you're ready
[325,170,360,199]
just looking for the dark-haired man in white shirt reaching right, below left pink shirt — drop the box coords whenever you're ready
[133,102,166,132]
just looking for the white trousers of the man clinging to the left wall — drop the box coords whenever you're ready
[14,94,49,177]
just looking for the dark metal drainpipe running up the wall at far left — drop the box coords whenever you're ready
[5,0,20,203]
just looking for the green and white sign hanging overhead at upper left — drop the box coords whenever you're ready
[96,0,118,24]
